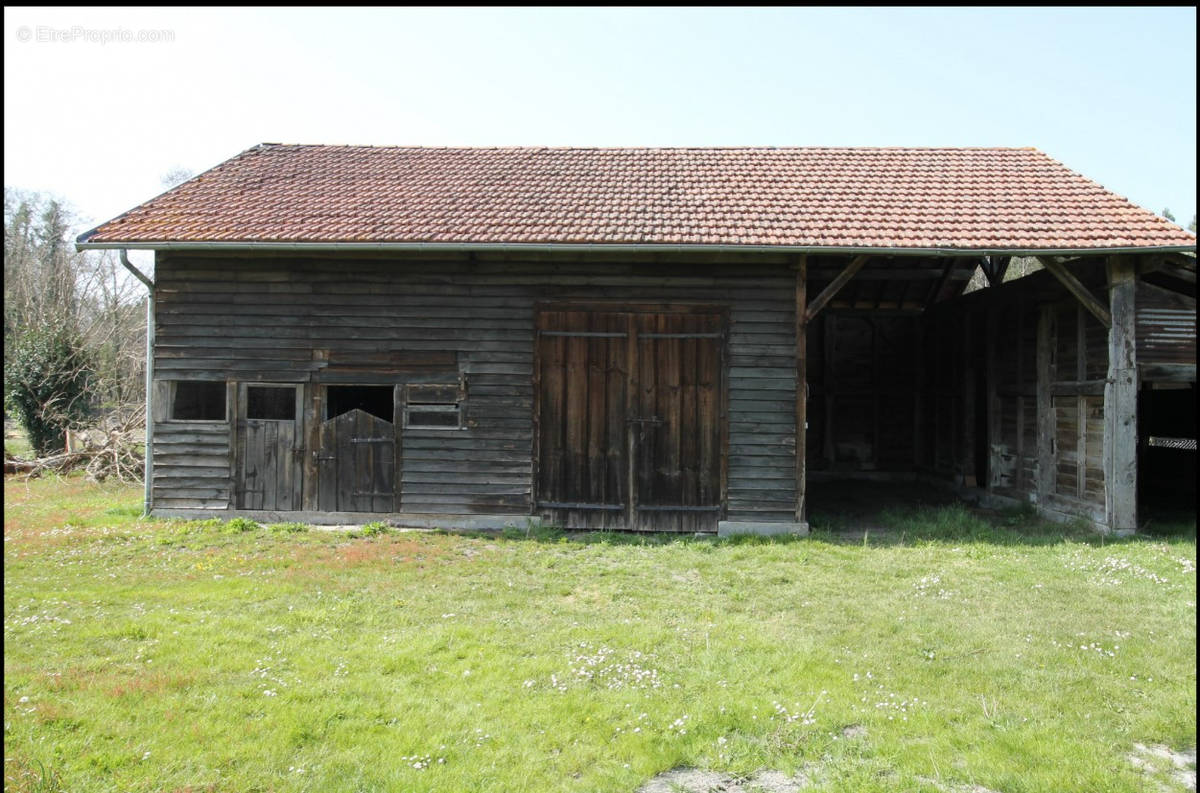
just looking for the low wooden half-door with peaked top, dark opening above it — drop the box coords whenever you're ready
[317,408,396,512]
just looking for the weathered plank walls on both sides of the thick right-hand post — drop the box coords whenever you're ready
[918,259,1195,528]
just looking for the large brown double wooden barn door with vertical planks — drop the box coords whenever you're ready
[535,308,725,531]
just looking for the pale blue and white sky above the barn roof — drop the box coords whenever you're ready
[4,8,1196,231]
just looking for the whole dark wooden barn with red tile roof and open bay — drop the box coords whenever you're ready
[78,144,1196,533]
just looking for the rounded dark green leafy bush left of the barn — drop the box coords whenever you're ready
[4,328,92,457]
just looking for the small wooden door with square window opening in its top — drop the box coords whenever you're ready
[236,383,304,511]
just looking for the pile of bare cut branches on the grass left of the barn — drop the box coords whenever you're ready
[4,408,145,482]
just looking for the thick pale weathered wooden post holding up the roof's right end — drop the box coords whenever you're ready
[1104,256,1138,530]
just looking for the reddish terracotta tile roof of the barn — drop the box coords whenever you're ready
[80,144,1196,250]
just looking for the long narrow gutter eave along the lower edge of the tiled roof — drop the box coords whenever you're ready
[76,235,1196,257]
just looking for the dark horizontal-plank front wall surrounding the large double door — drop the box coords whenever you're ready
[154,253,796,521]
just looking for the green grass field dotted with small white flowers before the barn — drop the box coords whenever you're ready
[4,479,1196,793]
